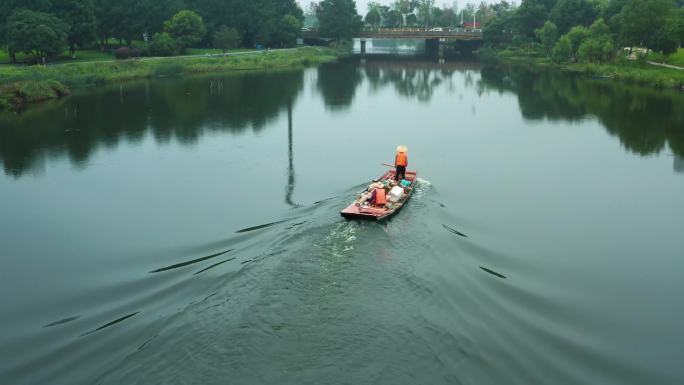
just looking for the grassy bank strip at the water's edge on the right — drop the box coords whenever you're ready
[479,49,684,90]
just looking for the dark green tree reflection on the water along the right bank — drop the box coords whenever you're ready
[479,66,684,155]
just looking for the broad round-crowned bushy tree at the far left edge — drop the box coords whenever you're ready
[5,9,69,63]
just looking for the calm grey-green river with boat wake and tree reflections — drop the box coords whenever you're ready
[0,55,684,385]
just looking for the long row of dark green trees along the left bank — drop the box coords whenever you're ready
[0,0,304,58]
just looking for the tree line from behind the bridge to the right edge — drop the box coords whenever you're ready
[352,0,684,62]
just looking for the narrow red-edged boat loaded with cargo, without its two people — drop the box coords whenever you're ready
[340,170,418,221]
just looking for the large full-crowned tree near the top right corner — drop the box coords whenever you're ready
[615,0,672,45]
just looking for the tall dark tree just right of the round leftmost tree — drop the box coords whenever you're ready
[52,0,97,57]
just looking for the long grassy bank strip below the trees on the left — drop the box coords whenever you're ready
[0,47,342,111]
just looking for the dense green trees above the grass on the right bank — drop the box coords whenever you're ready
[483,0,684,62]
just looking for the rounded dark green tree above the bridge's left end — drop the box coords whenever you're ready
[318,0,363,41]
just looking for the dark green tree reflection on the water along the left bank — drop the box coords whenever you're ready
[0,71,304,176]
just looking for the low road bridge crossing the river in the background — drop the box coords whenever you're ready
[302,28,482,55]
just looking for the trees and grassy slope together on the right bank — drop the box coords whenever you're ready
[470,0,684,90]
